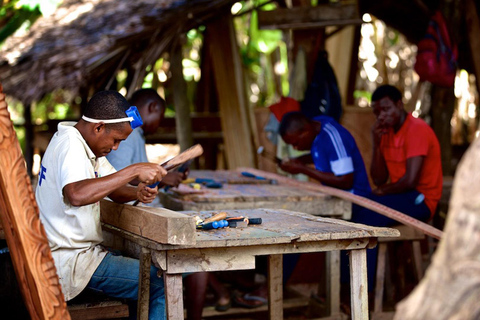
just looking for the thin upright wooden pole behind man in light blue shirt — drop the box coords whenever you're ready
[170,35,193,151]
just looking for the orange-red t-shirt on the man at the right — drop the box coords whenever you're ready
[380,114,443,216]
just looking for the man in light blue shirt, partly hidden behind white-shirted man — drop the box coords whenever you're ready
[107,89,188,187]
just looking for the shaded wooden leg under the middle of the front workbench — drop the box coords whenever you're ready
[268,254,283,320]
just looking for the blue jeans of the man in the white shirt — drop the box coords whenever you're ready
[87,252,167,320]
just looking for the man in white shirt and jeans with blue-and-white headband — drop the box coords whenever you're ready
[36,91,167,319]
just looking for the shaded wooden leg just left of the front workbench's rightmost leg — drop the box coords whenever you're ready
[326,251,340,317]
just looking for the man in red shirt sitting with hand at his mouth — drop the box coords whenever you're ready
[352,85,443,226]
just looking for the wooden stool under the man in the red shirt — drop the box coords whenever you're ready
[372,225,425,320]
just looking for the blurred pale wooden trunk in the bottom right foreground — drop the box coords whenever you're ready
[395,139,480,320]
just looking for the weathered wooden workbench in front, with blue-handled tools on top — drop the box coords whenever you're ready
[106,209,398,320]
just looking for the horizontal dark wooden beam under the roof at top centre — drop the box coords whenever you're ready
[258,3,362,29]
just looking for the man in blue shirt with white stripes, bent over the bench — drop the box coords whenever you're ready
[279,112,370,196]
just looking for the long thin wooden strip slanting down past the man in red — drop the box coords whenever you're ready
[237,168,443,239]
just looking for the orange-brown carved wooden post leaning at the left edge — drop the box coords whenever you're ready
[0,84,70,320]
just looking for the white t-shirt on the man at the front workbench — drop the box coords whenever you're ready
[35,122,116,300]
